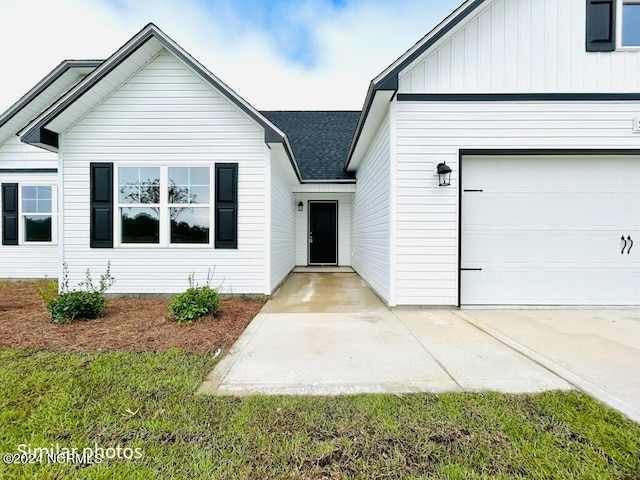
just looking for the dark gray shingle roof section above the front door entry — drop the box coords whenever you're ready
[260,111,360,181]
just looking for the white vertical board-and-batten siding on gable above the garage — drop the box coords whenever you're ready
[399,0,640,93]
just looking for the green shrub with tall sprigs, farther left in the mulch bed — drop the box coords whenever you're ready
[45,262,115,323]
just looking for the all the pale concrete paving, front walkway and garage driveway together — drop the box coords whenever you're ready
[199,273,640,421]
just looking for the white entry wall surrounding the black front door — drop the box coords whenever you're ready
[295,191,353,267]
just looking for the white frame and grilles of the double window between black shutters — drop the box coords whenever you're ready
[113,162,215,250]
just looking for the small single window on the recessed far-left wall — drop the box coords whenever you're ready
[21,186,53,243]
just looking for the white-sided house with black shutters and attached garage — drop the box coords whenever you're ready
[0,0,640,306]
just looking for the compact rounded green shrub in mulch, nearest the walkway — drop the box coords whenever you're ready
[169,273,220,323]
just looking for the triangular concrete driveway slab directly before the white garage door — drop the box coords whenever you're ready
[458,309,640,422]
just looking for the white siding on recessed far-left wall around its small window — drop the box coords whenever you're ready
[0,173,60,278]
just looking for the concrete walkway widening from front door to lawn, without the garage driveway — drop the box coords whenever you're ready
[199,273,571,395]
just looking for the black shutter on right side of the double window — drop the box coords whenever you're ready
[215,163,238,249]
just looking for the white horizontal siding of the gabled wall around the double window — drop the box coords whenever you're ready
[60,50,269,294]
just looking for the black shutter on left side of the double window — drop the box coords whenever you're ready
[89,163,113,248]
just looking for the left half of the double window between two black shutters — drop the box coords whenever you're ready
[118,167,160,243]
